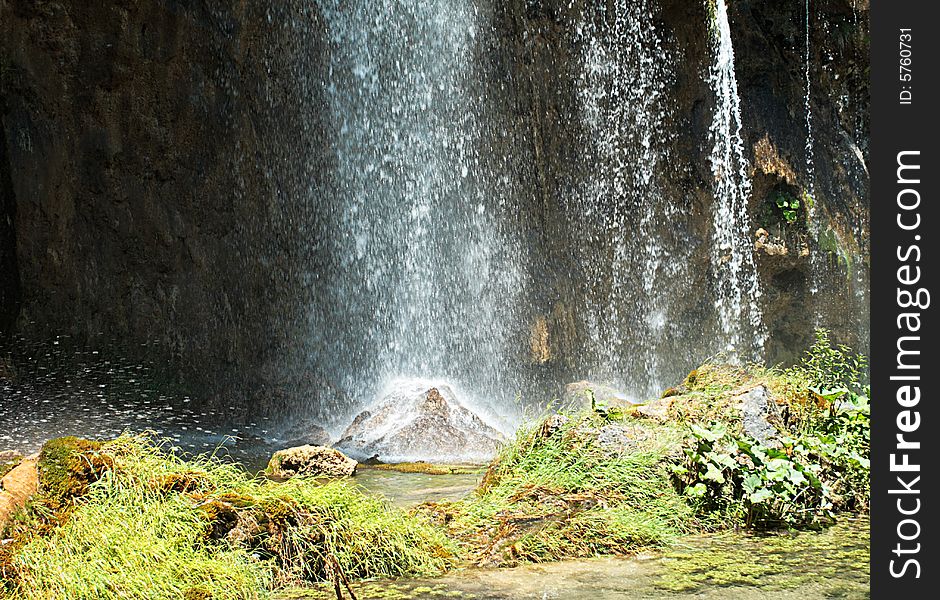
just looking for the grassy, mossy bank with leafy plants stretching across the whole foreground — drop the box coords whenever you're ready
[0,332,869,600]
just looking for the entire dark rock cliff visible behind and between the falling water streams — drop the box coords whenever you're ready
[0,0,869,409]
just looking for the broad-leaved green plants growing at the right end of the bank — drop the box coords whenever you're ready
[673,392,870,528]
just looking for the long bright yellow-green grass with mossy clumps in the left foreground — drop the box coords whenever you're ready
[0,435,452,600]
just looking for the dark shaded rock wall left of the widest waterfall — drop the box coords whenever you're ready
[0,0,332,409]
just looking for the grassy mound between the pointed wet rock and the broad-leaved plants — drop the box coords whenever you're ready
[422,413,694,566]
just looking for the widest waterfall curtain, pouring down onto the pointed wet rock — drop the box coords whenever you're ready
[309,0,521,424]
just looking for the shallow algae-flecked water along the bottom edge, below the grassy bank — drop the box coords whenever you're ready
[280,519,870,600]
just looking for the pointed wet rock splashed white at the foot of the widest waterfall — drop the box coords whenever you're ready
[337,382,504,462]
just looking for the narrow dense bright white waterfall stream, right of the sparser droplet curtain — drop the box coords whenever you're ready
[708,0,766,359]
